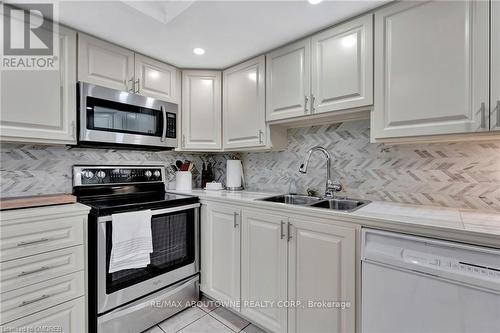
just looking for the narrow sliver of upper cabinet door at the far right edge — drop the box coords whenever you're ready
[490,1,500,131]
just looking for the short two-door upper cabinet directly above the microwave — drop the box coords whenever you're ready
[78,33,180,103]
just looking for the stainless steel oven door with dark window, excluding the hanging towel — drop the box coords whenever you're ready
[97,203,200,314]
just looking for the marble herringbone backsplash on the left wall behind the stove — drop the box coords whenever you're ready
[0,143,235,197]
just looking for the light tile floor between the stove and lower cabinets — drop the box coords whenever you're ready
[143,298,266,333]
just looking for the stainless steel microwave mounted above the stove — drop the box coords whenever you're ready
[78,82,178,149]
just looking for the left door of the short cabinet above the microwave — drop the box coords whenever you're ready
[78,34,134,91]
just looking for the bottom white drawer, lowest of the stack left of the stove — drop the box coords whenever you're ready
[0,297,85,333]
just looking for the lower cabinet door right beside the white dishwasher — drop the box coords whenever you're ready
[288,219,356,333]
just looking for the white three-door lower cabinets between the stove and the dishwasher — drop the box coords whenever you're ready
[201,203,358,333]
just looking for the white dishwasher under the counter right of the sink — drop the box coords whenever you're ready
[361,229,500,333]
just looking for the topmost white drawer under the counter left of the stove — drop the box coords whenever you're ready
[0,216,86,262]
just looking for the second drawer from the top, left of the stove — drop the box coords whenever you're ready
[0,245,85,293]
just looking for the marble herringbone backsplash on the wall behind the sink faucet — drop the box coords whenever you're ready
[241,120,500,212]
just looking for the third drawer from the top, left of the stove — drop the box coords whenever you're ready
[0,271,85,324]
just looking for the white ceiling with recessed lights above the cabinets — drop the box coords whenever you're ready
[59,0,387,69]
